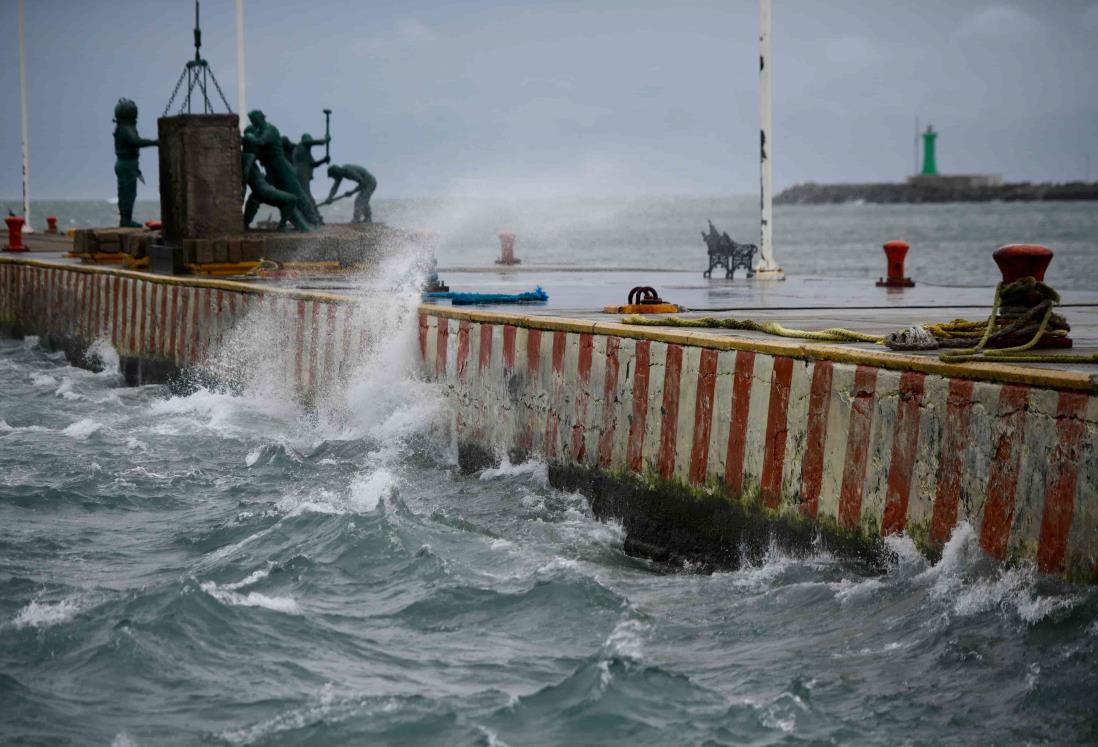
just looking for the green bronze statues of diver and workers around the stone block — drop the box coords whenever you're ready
[114,99,378,231]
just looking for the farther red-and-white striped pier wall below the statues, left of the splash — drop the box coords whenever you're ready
[0,260,367,399]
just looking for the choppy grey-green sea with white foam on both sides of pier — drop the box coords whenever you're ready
[0,195,1098,747]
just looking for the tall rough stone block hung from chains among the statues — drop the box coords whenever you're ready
[157,114,244,247]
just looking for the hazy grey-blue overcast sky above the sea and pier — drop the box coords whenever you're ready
[0,0,1098,198]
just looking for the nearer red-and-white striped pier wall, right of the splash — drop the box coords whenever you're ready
[419,309,1098,581]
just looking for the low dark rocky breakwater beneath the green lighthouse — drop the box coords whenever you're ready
[774,181,1098,205]
